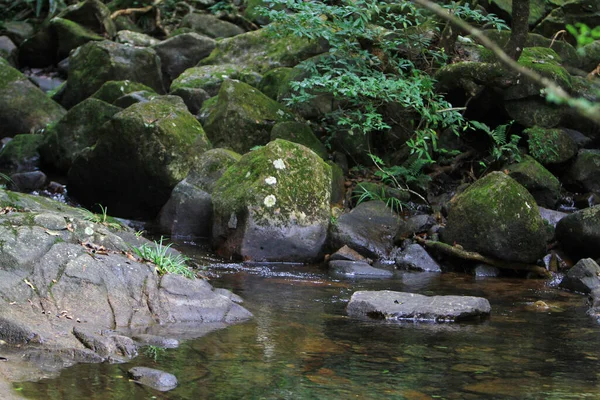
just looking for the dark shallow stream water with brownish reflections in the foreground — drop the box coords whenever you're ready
[15,245,600,400]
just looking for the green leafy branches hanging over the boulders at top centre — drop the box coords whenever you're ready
[265,0,505,163]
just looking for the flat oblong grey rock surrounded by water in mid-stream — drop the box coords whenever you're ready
[346,290,491,322]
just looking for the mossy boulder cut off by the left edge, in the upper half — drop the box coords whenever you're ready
[0,59,66,138]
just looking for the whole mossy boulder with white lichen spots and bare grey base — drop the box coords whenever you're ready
[212,139,331,262]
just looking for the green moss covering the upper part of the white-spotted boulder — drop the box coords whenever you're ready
[213,139,331,225]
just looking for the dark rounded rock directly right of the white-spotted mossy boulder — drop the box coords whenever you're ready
[330,201,398,258]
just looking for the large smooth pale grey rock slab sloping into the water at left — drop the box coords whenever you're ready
[0,190,251,354]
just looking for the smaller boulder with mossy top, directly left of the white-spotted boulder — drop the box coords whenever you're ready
[157,149,241,239]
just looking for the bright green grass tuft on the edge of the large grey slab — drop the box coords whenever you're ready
[133,236,196,279]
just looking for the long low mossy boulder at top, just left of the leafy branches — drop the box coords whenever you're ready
[200,29,327,74]
